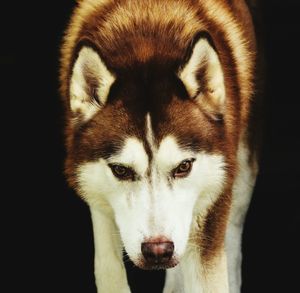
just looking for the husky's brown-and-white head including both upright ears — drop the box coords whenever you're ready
[68,39,226,269]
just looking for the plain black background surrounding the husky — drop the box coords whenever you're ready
[0,0,300,293]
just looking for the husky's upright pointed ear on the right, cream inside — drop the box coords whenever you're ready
[178,38,225,120]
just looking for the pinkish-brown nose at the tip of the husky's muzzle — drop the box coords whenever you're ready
[141,241,174,265]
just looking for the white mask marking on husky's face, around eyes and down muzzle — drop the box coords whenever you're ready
[78,133,225,263]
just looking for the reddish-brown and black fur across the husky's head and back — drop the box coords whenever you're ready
[60,0,256,261]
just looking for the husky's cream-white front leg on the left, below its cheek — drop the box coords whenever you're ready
[90,207,130,293]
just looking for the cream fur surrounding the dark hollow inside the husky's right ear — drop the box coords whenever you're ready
[179,38,225,105]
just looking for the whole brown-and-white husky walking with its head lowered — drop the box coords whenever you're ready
[60,0,258,293]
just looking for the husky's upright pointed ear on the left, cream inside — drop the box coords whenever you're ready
[70,47,115,120]
